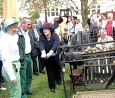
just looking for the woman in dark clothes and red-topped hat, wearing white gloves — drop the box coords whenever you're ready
[39,23,61,92]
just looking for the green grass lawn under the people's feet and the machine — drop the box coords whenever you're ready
[0,64,85,98]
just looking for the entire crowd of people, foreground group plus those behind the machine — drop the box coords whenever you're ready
[0,13,115,98]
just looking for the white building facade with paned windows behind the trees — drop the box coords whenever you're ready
[39,0,115,22]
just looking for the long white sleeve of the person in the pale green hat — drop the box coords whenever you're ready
[1,40,16,81]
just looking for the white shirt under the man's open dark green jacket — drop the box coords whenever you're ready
[22,30,31,54]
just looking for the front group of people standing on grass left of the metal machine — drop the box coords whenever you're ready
[0,17,61,98]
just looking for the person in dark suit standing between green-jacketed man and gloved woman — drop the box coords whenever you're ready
[32,19,45,75]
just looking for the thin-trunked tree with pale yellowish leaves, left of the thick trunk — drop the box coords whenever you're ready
[19,0,68,21]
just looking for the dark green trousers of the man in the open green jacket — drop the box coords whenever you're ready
[20,54,32,98]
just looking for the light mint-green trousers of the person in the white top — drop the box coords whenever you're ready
[2,61,21,98]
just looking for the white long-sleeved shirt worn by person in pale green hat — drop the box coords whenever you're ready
[0,33,20,81]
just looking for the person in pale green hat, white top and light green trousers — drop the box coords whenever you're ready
[0,18,21,98]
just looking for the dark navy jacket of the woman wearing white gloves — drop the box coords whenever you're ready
[39,33,60,66]
